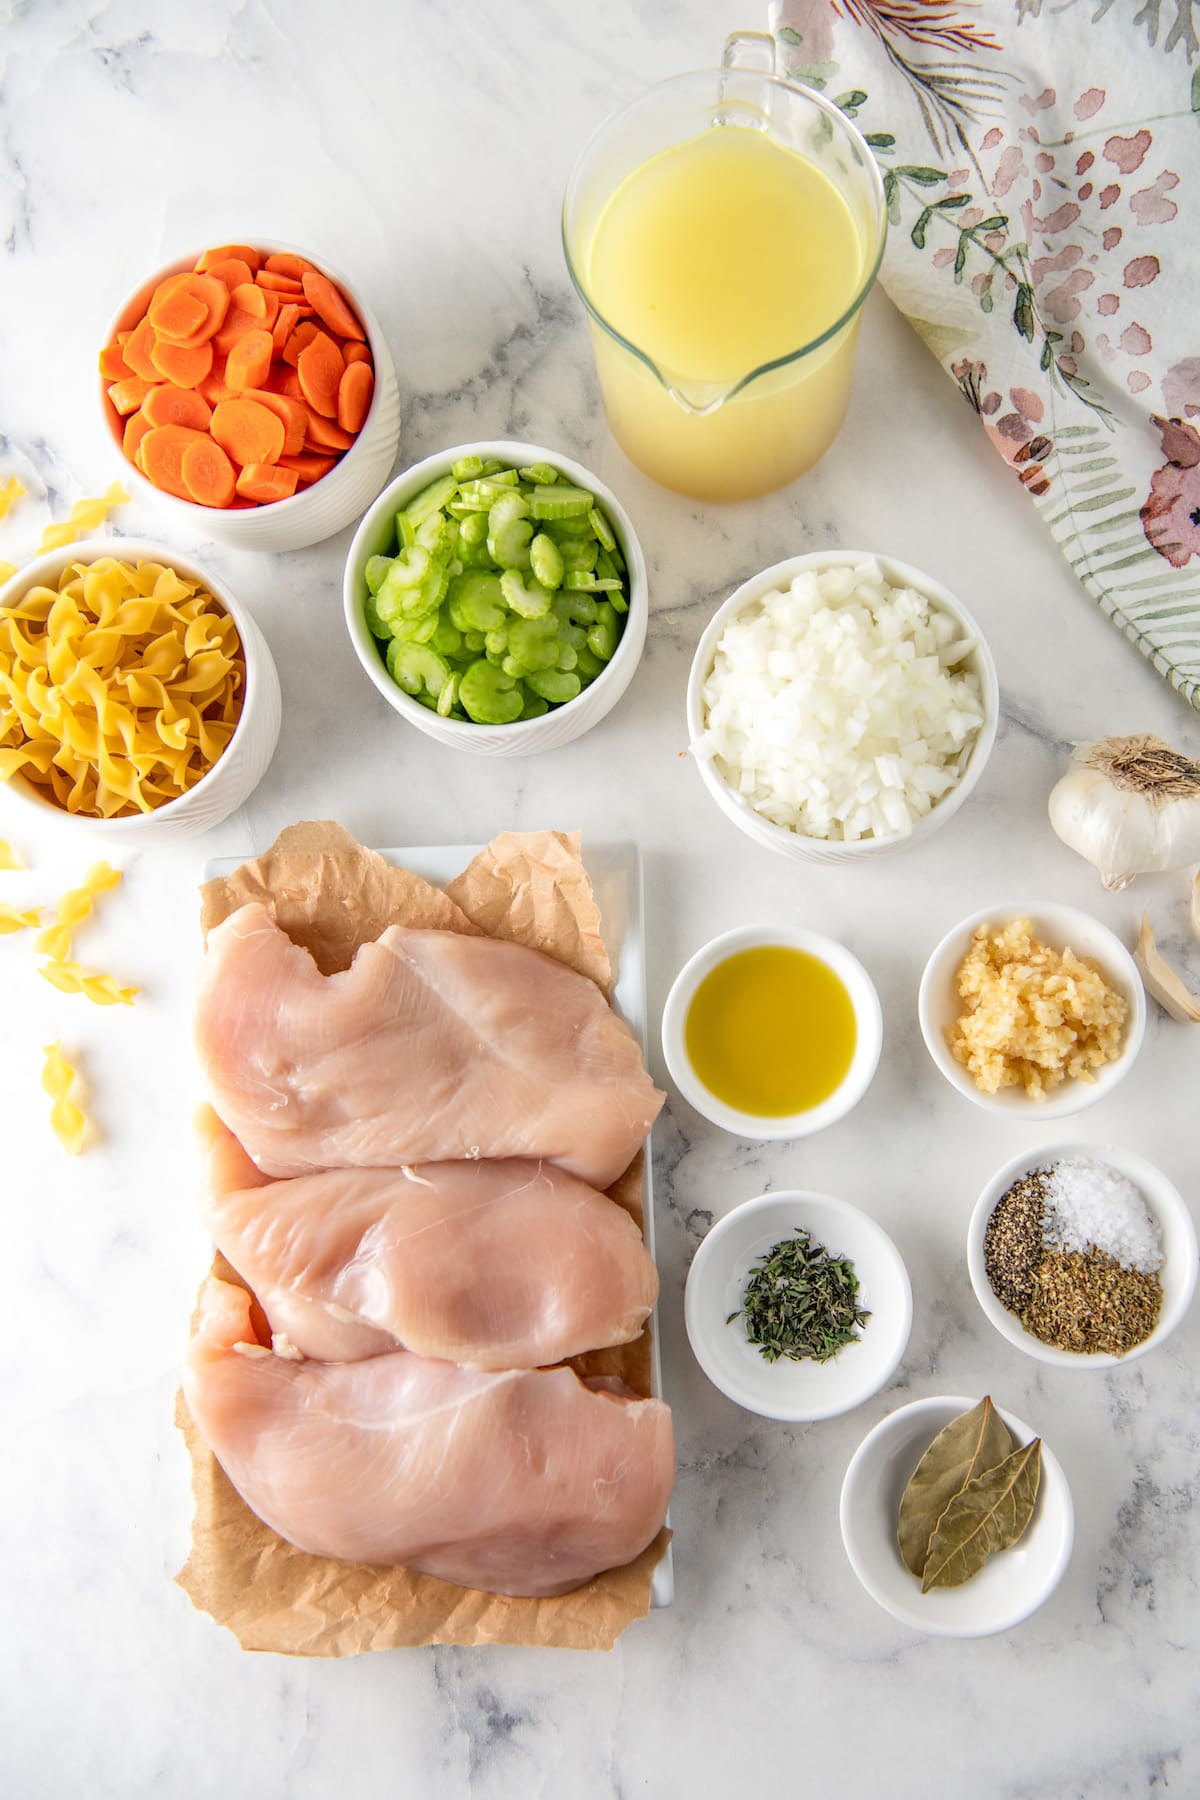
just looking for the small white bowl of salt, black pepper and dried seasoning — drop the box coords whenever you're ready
[966,1143,1198,1368]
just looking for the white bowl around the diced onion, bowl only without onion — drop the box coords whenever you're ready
[687,551,1000,862]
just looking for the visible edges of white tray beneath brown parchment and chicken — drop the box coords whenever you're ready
[205,842,675,1606]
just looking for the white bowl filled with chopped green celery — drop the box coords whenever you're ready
[344,439,648,756]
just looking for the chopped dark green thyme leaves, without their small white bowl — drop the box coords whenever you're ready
[725,1226,871,1363]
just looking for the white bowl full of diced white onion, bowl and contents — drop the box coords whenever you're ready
[687,551,1000,862]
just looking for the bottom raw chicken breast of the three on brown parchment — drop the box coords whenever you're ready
[184,1278,675,1595]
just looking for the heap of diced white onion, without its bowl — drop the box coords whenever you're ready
[691,560,984,842]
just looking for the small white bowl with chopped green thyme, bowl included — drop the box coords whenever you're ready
[684,1188,912,1420]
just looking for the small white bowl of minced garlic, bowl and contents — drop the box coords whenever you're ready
[918,900,1146,1120]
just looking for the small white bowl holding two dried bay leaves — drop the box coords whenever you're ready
[840,1395,1074,1638]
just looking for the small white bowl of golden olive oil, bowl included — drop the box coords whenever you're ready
[662,925,883,1139]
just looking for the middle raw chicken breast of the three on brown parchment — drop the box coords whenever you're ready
[198,1107,658,1368]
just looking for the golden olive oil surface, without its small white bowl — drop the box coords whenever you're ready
[684,945,858,1118]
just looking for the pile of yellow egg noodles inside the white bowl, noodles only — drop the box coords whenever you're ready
[0,556,245,819]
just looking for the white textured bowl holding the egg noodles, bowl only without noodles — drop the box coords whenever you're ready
[0,536,281,848]
